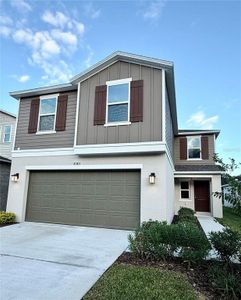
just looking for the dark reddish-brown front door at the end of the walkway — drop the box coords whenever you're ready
[194,180,210,212]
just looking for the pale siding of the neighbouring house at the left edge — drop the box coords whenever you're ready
[0,111,16,158]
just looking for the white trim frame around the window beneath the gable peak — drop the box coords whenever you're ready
[104,78,132,127]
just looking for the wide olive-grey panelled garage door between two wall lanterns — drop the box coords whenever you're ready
[26,170,140,229]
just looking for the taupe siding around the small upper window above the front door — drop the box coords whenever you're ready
[174,134,215,165]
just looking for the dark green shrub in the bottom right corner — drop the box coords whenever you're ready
[208,265,241,300]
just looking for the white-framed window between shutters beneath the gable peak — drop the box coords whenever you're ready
[106,78,131,125]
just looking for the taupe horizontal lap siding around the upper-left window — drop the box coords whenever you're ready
[15,92,77,150]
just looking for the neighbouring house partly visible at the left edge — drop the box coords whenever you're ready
[0,110,16,211]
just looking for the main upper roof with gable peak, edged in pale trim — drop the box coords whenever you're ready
[10,51,178,134]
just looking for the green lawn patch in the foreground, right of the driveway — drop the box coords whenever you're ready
[83,264,198,300]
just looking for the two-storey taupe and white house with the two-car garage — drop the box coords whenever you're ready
[7,52,222,229]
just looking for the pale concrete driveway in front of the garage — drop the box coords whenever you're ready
[0,223,130,300]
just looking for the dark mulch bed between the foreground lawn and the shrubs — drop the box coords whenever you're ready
[117,252,237,300]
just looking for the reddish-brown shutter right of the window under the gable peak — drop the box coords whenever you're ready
[130,80,143,122]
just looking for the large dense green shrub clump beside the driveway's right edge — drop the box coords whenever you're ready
[129,221,210,263]
